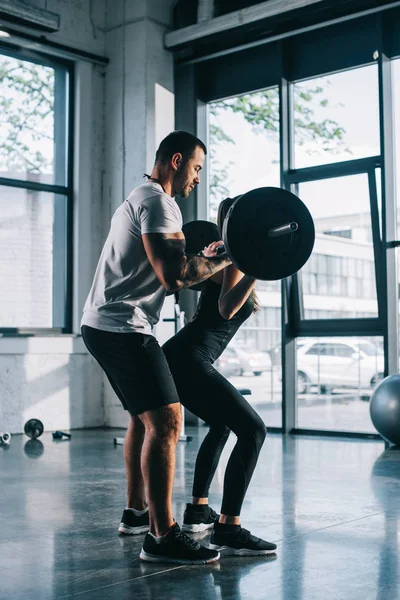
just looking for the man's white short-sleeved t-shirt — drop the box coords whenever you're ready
[81,181,182,334]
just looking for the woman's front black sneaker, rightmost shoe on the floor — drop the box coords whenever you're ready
[210,524,276,556]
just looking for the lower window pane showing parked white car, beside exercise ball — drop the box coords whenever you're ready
[297,337,384,433]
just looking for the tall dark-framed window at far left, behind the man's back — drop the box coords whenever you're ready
[0,53,72,332]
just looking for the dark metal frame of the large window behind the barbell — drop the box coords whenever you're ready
[175,7,400,440]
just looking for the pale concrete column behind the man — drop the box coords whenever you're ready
[104,0,175,427]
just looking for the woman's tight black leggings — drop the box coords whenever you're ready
[163,350,267,516]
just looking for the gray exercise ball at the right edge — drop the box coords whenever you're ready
[369,375,400,446]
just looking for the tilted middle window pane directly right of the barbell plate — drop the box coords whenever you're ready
[299,174,378,319]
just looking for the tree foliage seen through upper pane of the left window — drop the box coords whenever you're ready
[0,55,54,178]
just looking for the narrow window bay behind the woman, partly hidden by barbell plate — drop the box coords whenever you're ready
[209,88,282,427]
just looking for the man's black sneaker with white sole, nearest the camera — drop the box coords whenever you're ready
[140,523,219,565]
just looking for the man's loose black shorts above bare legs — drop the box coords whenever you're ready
[81,325,179,415]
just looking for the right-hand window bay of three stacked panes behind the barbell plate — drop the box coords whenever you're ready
[291,64,384,433]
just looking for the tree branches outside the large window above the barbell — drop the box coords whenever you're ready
[209,82,349,215]
